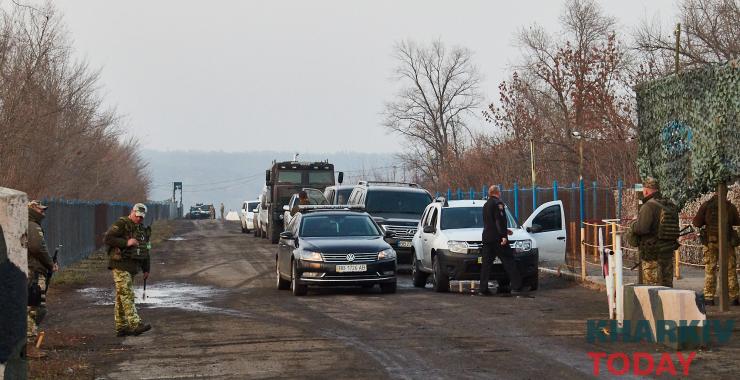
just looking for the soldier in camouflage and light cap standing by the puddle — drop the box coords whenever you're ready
[105,203,152,336]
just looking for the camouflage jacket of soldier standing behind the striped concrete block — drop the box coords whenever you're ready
[629,192,678,258]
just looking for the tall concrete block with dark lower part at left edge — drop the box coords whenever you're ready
[0,187,28,380]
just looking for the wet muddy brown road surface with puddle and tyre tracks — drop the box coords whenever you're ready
[31,220,740,379]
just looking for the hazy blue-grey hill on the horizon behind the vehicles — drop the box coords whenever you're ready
[142,150,404,210]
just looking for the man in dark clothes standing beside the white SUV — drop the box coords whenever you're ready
[478,186,522,296]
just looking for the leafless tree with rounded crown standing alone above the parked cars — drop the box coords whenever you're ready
[384,41,481,185]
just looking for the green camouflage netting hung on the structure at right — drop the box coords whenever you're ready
[636,61,740,206]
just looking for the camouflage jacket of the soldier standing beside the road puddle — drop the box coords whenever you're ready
[105,216,151,274]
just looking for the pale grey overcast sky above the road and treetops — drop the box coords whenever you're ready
[44,0,676,152]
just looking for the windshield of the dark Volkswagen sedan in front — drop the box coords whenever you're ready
[300,214,381,237]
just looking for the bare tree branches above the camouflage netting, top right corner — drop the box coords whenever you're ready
[635,0,740,77]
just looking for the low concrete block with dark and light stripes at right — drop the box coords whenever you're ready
[623,284,707,350]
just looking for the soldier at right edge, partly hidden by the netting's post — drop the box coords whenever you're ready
[693,194,740,306]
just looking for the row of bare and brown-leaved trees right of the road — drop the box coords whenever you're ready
[384,0,740,189]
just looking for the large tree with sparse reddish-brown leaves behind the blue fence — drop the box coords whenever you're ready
[484,0,635,182]
